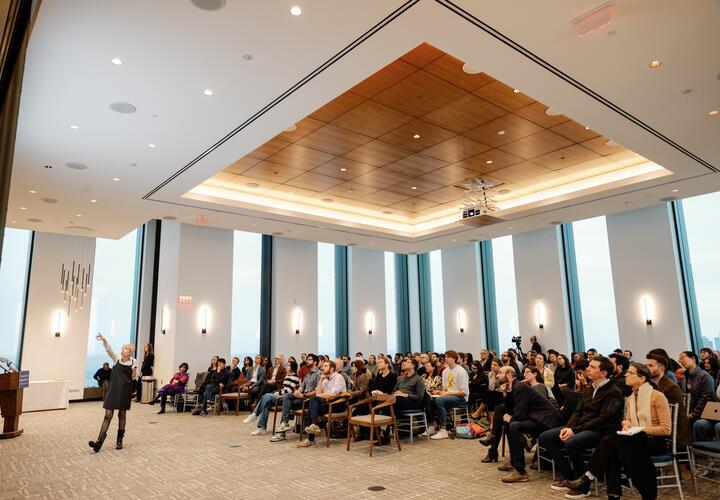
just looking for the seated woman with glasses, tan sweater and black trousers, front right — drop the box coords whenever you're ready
[565,364,672,499]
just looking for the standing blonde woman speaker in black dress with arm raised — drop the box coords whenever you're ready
[88,332,137,453]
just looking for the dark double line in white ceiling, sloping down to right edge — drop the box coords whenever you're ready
[435,0,720,172]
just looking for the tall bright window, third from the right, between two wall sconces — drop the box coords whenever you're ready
[492,236,518,354]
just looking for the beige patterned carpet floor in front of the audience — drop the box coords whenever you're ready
[0,402,718,500]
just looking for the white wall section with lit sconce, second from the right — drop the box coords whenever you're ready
[513,227,572,353]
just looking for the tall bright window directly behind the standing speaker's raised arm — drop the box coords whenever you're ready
[85,229,142,387]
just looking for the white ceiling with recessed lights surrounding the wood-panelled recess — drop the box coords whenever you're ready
[7,0,720,252]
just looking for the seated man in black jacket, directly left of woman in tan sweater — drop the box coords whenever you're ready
[540,356,623,491]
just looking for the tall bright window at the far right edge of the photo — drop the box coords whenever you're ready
[681,193,720,349]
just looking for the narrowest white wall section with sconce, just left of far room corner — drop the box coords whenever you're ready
[348,248,387,358]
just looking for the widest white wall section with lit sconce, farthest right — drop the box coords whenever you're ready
[607,204,690,359]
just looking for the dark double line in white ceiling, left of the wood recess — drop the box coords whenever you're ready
[143,0,420,200]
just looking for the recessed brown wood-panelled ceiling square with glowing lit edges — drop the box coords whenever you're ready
[217,44,644,218]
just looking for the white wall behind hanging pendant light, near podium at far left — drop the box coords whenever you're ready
[21,233,95,400]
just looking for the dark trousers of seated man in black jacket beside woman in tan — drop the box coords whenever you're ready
[540,427,603,479]
